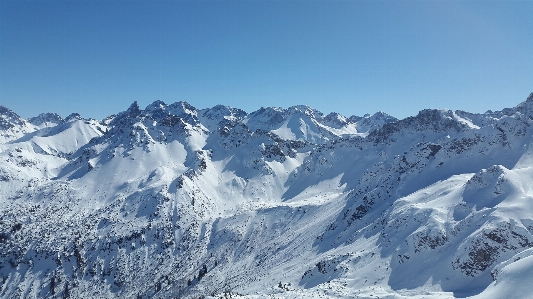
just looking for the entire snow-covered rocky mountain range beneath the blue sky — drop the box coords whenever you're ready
[0,93,533,298]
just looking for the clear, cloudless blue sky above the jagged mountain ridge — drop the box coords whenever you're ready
[0,0,533,119]
